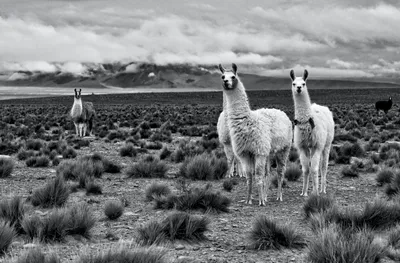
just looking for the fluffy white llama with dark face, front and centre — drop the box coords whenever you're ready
[219,64,292,206]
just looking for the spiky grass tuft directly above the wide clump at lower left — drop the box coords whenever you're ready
[31,176,70,208]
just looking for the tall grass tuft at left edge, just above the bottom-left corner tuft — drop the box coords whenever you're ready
[0,196,25,234]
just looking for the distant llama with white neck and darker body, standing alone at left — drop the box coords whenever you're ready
[70,89,96,137]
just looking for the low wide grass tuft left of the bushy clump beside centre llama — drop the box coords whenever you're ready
[126,158,168,178]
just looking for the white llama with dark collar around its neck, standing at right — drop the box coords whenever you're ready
[290,70,335,196]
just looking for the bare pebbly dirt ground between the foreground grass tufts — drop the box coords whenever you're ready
[0,136,390,263]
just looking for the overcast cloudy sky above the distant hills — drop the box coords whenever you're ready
[0,0,400,78]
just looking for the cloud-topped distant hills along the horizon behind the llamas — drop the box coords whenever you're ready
[0,63,400,91]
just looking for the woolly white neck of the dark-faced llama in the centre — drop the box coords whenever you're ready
[224,78,251,120]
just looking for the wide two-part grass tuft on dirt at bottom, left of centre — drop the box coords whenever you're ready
[137,212,210,245]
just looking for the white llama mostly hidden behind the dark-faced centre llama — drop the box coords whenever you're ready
[217,93,244,178]
